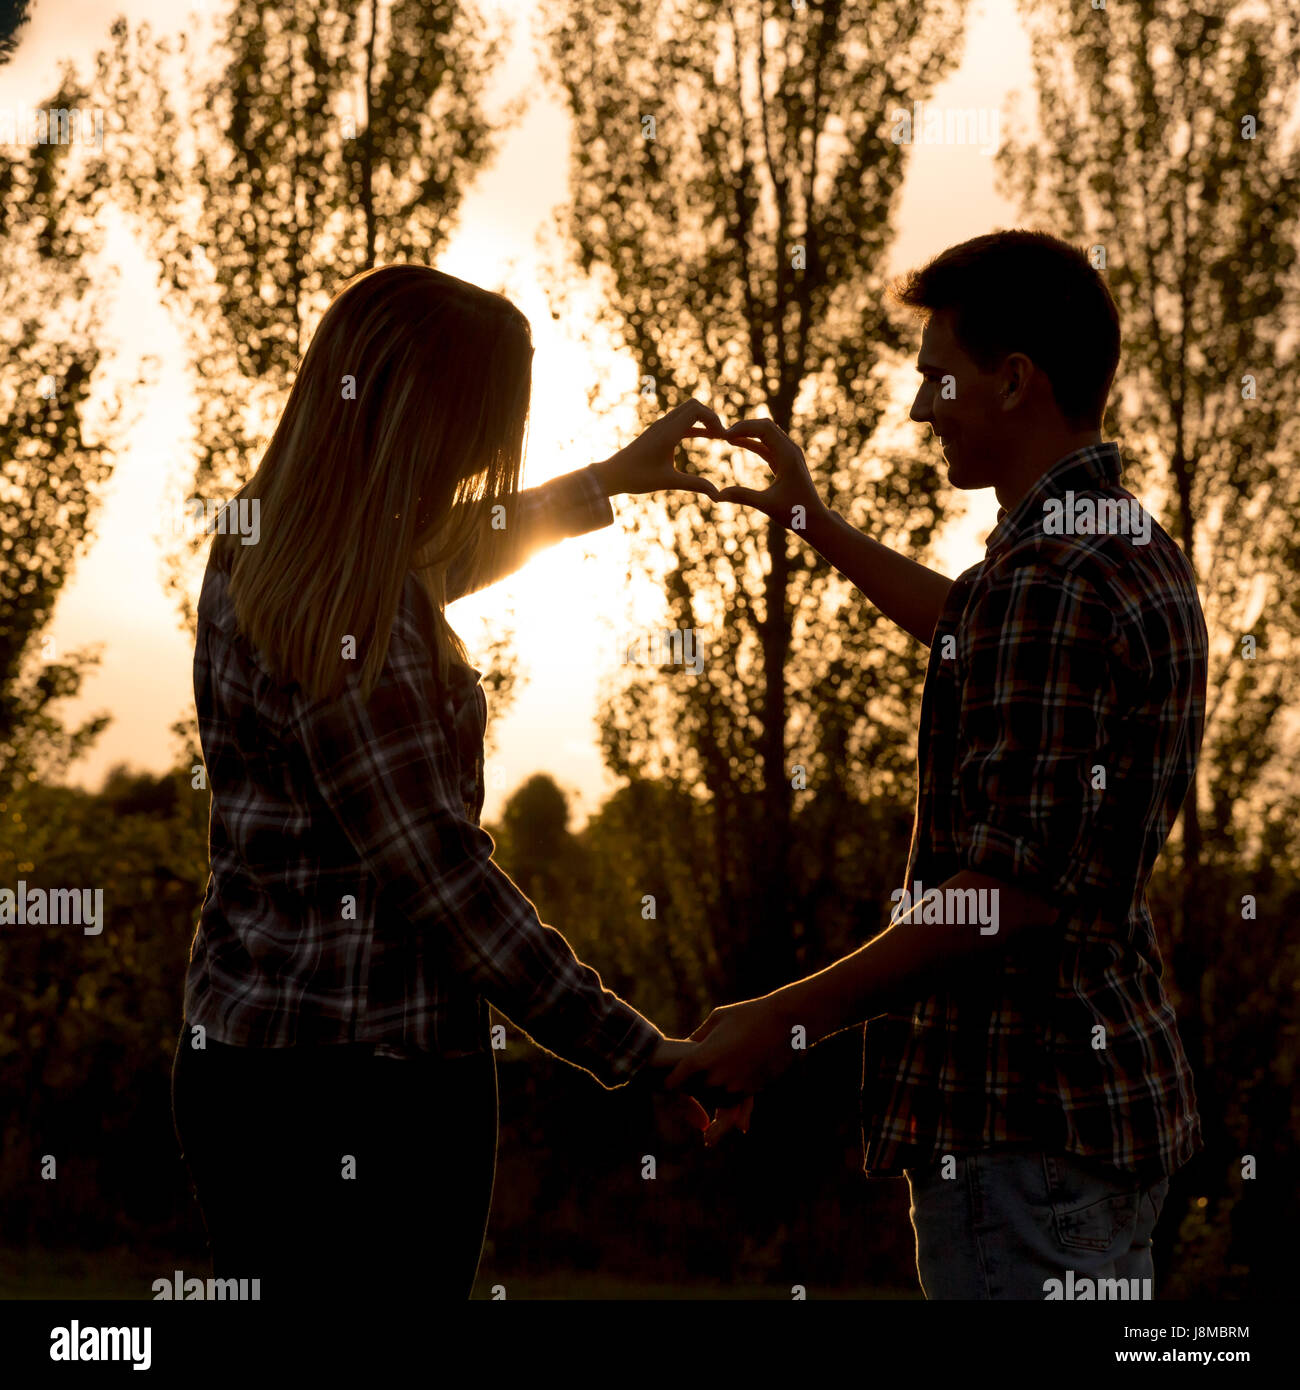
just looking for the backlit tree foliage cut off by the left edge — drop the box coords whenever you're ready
[0,78,121,795]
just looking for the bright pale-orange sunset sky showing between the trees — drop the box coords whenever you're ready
[0,0,1030,820]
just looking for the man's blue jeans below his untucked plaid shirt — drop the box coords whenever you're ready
[905,1151,1169,1300]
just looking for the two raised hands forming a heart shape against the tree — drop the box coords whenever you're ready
[595,399,819,523]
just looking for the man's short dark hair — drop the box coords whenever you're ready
[890,231,1119,430]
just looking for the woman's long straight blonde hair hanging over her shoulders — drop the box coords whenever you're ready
[211,265,533,699]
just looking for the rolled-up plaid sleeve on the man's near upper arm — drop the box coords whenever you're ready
[958,560,1126,899]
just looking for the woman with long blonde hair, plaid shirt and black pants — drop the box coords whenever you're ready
[172,265,739,1298]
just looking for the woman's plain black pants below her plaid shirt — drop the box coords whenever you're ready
[172,1026,498,1302]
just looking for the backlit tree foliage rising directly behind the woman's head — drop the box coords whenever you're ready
[77,0,513,709]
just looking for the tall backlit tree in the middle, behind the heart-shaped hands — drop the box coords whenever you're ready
[546,0,964,992]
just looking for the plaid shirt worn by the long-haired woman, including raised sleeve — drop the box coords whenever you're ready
[185,470,662,1087]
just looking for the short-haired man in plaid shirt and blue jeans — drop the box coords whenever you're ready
[667,231,1208,1298]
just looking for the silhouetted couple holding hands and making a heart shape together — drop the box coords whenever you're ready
[174,232,1207,1298]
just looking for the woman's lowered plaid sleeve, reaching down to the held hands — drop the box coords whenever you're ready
[295,610,663,1087]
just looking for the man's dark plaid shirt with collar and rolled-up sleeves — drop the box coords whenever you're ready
[862,443,1208,1176]
